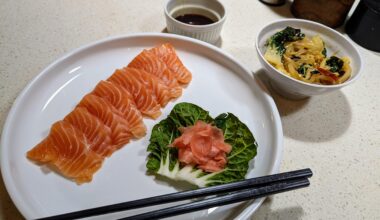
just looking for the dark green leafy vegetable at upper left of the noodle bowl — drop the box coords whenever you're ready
[267,26,305,56]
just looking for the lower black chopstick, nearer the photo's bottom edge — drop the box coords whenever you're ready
[119,177,310,220]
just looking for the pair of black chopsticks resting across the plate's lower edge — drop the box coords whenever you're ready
[39,169,313,220]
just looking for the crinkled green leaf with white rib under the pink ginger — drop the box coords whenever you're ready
[146,103,257,187]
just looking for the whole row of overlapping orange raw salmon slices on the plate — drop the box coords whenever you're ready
[27,44,191,184]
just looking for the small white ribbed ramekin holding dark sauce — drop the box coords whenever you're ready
[165,0,226,43]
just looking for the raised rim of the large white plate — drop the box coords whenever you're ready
[0,32,284,219]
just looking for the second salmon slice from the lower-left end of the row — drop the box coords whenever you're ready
[63,107,115,157]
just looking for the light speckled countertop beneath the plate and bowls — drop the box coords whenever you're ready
[0,0,380,219]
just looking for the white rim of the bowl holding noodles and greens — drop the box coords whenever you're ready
[255,18,363,88]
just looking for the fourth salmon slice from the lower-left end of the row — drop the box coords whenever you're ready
[107,69,161,119]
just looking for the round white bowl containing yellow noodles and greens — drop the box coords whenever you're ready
[256,19,362,99]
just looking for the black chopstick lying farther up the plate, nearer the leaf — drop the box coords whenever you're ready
[39,169,313,220]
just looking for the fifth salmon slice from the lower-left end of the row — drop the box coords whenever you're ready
[123,67,175,107]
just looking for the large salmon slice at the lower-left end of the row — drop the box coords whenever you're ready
[27,121,104,184]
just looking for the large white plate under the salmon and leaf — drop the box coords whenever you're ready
[1,33,283,219]
